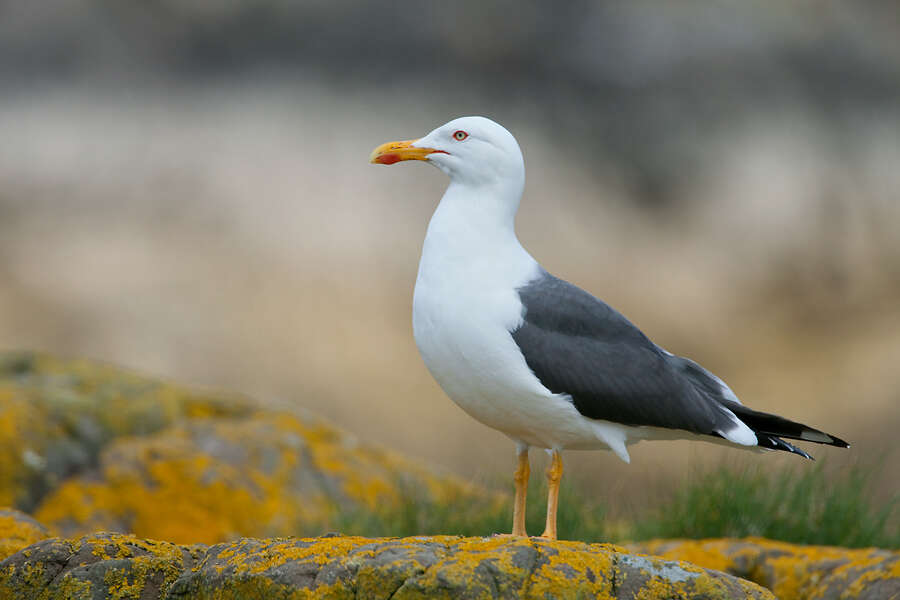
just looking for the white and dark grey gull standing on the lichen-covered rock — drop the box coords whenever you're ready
[370,117,849,539]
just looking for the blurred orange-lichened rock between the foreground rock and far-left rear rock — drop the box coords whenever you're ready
[35,413,486,543]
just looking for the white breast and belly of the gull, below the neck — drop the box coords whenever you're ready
[413,188,598,448]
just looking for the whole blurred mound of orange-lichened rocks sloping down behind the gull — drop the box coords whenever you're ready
[0,353,492,544]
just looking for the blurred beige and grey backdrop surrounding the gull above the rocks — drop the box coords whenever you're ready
[0,0,900,511]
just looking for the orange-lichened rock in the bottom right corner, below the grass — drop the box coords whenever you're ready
[629,538,900,600]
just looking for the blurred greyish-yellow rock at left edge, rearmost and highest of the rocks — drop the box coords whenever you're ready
[0,352,252,512]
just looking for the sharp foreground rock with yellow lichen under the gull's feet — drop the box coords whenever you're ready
[0,534,773,600]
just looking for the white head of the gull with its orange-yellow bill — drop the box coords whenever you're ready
[369,117,525,186]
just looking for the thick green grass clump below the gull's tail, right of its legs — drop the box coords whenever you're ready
[633,463,900,548]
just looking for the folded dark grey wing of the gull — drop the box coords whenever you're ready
[511,272,734,435]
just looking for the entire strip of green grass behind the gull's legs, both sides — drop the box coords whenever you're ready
[333,463,900,548]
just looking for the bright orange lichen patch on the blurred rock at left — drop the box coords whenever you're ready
[36,426,332,543]
